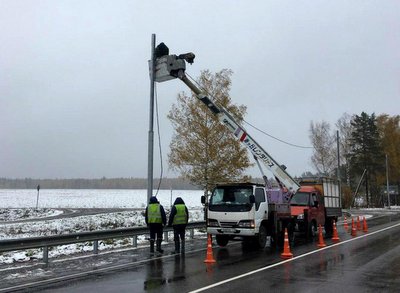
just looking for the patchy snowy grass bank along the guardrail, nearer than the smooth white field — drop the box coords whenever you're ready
[0,205,204,265]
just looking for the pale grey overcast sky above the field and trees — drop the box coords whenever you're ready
[0,0,400,178]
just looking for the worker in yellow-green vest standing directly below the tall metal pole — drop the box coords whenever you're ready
[144,196,167,254]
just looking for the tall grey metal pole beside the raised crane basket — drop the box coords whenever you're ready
[147,34,156,202]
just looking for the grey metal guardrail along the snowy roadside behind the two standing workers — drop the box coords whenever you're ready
[0,221,206,263]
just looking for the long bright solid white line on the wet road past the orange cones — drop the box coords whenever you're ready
[189,223,400,293]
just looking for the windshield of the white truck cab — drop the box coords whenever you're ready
[209,186,253,212]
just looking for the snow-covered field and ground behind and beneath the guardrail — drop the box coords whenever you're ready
[0,189,204,264]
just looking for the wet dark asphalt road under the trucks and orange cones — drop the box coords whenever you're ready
[35,210,400,293]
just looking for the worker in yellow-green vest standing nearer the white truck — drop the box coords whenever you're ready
[168,197,189,253]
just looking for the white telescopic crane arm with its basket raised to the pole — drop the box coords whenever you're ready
[155,49,300,193]
